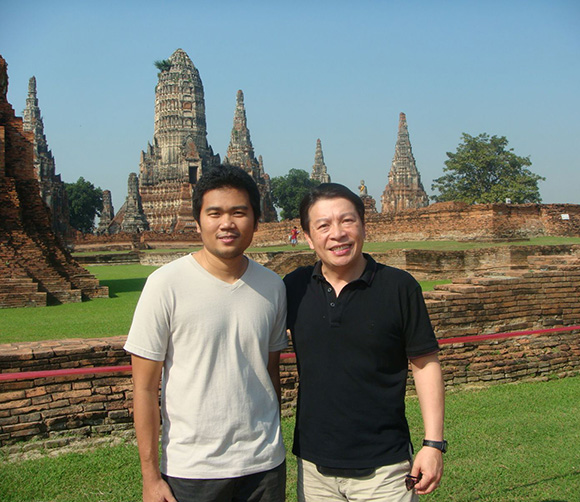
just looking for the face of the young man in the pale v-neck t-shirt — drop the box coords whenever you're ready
[198,187,256,259]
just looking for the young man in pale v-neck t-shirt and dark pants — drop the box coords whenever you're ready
[125,166,287,502]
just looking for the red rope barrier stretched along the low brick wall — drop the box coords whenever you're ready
[0,326,580,381]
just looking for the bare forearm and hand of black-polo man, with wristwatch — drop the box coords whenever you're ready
[411,354,445,495]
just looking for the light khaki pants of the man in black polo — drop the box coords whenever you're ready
[298,458,419,502]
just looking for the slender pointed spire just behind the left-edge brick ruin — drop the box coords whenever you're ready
[22,77,72,236]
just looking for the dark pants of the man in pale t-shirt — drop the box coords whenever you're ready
[163,461,286,502]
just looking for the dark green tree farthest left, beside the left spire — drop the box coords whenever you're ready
[65,176,103,234]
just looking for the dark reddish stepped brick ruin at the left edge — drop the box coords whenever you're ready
[0,56,108,308]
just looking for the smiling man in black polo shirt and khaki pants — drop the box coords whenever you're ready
[284,183,447,502]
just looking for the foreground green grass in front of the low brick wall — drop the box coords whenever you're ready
[0,377,580,502]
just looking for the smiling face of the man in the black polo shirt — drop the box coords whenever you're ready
[306,198,365,271]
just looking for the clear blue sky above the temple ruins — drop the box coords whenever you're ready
[0,0,580,210]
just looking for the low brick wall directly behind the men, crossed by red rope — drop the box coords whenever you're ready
[0,255,580,446]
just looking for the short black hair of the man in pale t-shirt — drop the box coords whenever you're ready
[192,165,262,224]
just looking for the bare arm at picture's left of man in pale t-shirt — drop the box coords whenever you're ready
[131,355,177,502]
